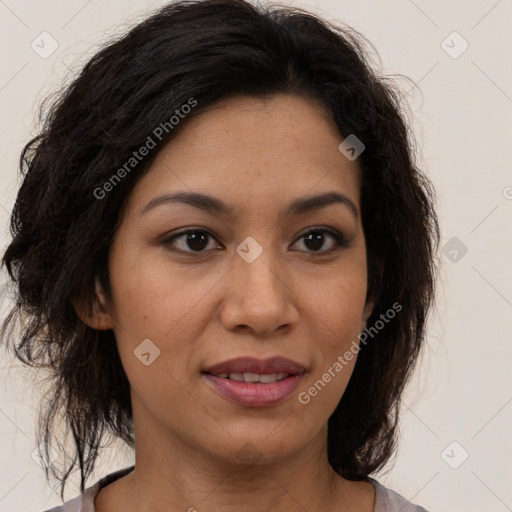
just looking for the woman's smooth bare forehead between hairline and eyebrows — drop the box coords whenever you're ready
[126,94,360,215]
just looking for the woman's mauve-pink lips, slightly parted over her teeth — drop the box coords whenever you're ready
[203,357,305,407]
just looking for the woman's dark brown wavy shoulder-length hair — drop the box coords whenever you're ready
[2,0,439,494]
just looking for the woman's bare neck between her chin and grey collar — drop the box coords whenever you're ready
[95,400,373,512]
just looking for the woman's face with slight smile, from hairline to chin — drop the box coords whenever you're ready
[90,94,370,463]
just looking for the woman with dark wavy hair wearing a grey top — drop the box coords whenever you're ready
[3,0,439,512]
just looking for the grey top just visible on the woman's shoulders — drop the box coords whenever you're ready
[45,466,428,512]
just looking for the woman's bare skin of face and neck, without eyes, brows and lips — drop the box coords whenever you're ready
[78,94,375,512]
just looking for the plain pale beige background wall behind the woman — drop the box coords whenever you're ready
[0,0,512,512]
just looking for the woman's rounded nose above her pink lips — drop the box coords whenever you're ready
[220,246,299,336]
